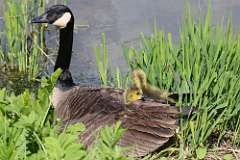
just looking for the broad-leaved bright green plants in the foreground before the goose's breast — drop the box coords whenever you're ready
[0,70,127,160]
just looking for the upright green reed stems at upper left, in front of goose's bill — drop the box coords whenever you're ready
[0,0,43,78]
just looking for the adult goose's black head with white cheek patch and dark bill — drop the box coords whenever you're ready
[31,5,74,29]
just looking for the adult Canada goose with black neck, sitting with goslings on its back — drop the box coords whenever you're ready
[32,5,189,156]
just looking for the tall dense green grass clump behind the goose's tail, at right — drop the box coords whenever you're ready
[97,1,240,159]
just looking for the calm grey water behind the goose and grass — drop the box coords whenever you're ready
[0,0,240,83]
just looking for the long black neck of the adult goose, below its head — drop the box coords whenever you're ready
[54,17,74,86]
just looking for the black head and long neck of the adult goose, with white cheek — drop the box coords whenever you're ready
[31,5,74,86]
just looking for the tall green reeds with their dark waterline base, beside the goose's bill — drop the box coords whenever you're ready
[0,0,67,94]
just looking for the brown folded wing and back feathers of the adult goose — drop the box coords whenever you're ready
[56,87,178,156]
